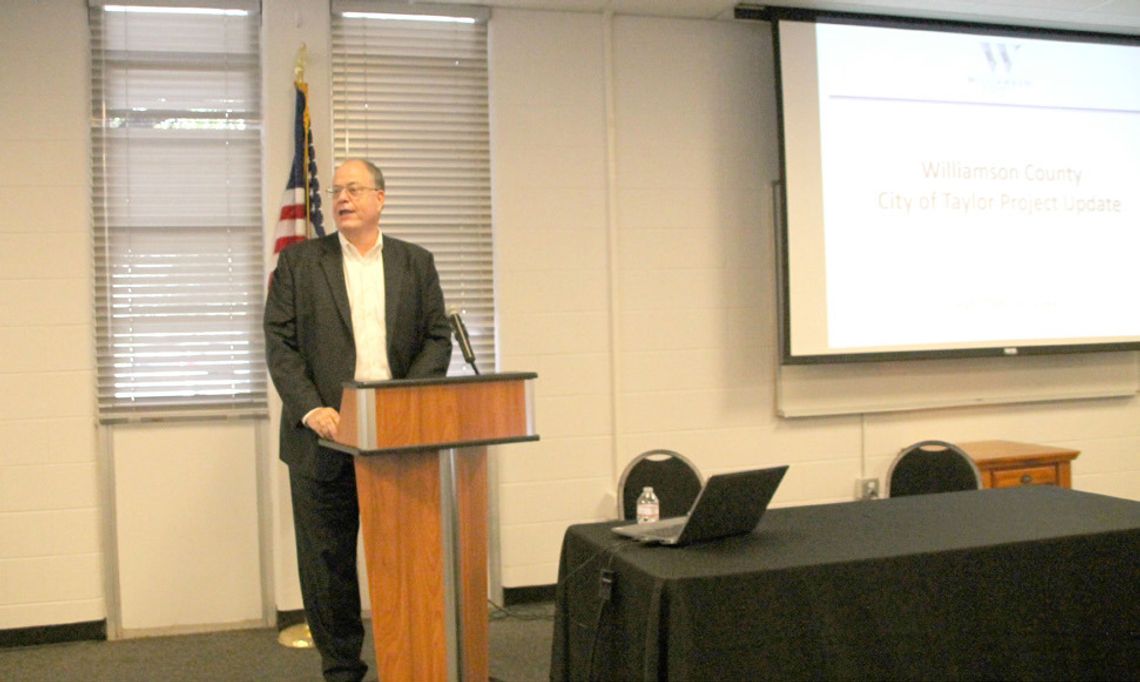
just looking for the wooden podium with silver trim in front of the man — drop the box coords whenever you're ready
[323,373,538,682]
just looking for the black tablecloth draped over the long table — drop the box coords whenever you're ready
[551,486,1140,680]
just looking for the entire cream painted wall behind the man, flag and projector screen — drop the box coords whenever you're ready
[0,0,1140,628]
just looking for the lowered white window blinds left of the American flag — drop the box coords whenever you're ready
[89,0,266,422]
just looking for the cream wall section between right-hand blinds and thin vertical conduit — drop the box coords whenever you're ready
[489,10,613,587]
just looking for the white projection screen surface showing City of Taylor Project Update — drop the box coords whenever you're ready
[781,19,1140,354]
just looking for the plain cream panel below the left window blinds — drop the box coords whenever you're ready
[111,420,262,636]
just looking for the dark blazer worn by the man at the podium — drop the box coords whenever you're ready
[264,233,451,480]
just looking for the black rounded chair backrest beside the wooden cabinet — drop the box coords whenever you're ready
[887,440,982,497]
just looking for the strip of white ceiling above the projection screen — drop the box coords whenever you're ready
[428,0,1140,34]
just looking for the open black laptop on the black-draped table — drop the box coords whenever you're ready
[613,464,788,545]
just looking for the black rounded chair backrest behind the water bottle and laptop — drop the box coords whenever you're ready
[618,449,703,520]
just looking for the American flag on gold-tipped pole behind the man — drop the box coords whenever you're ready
[269,79,325,273]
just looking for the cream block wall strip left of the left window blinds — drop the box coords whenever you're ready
[0,0,105,628]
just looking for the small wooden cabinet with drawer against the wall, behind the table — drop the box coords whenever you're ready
[958,440,1081,488]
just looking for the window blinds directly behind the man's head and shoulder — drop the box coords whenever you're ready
[332,0,495,374]
